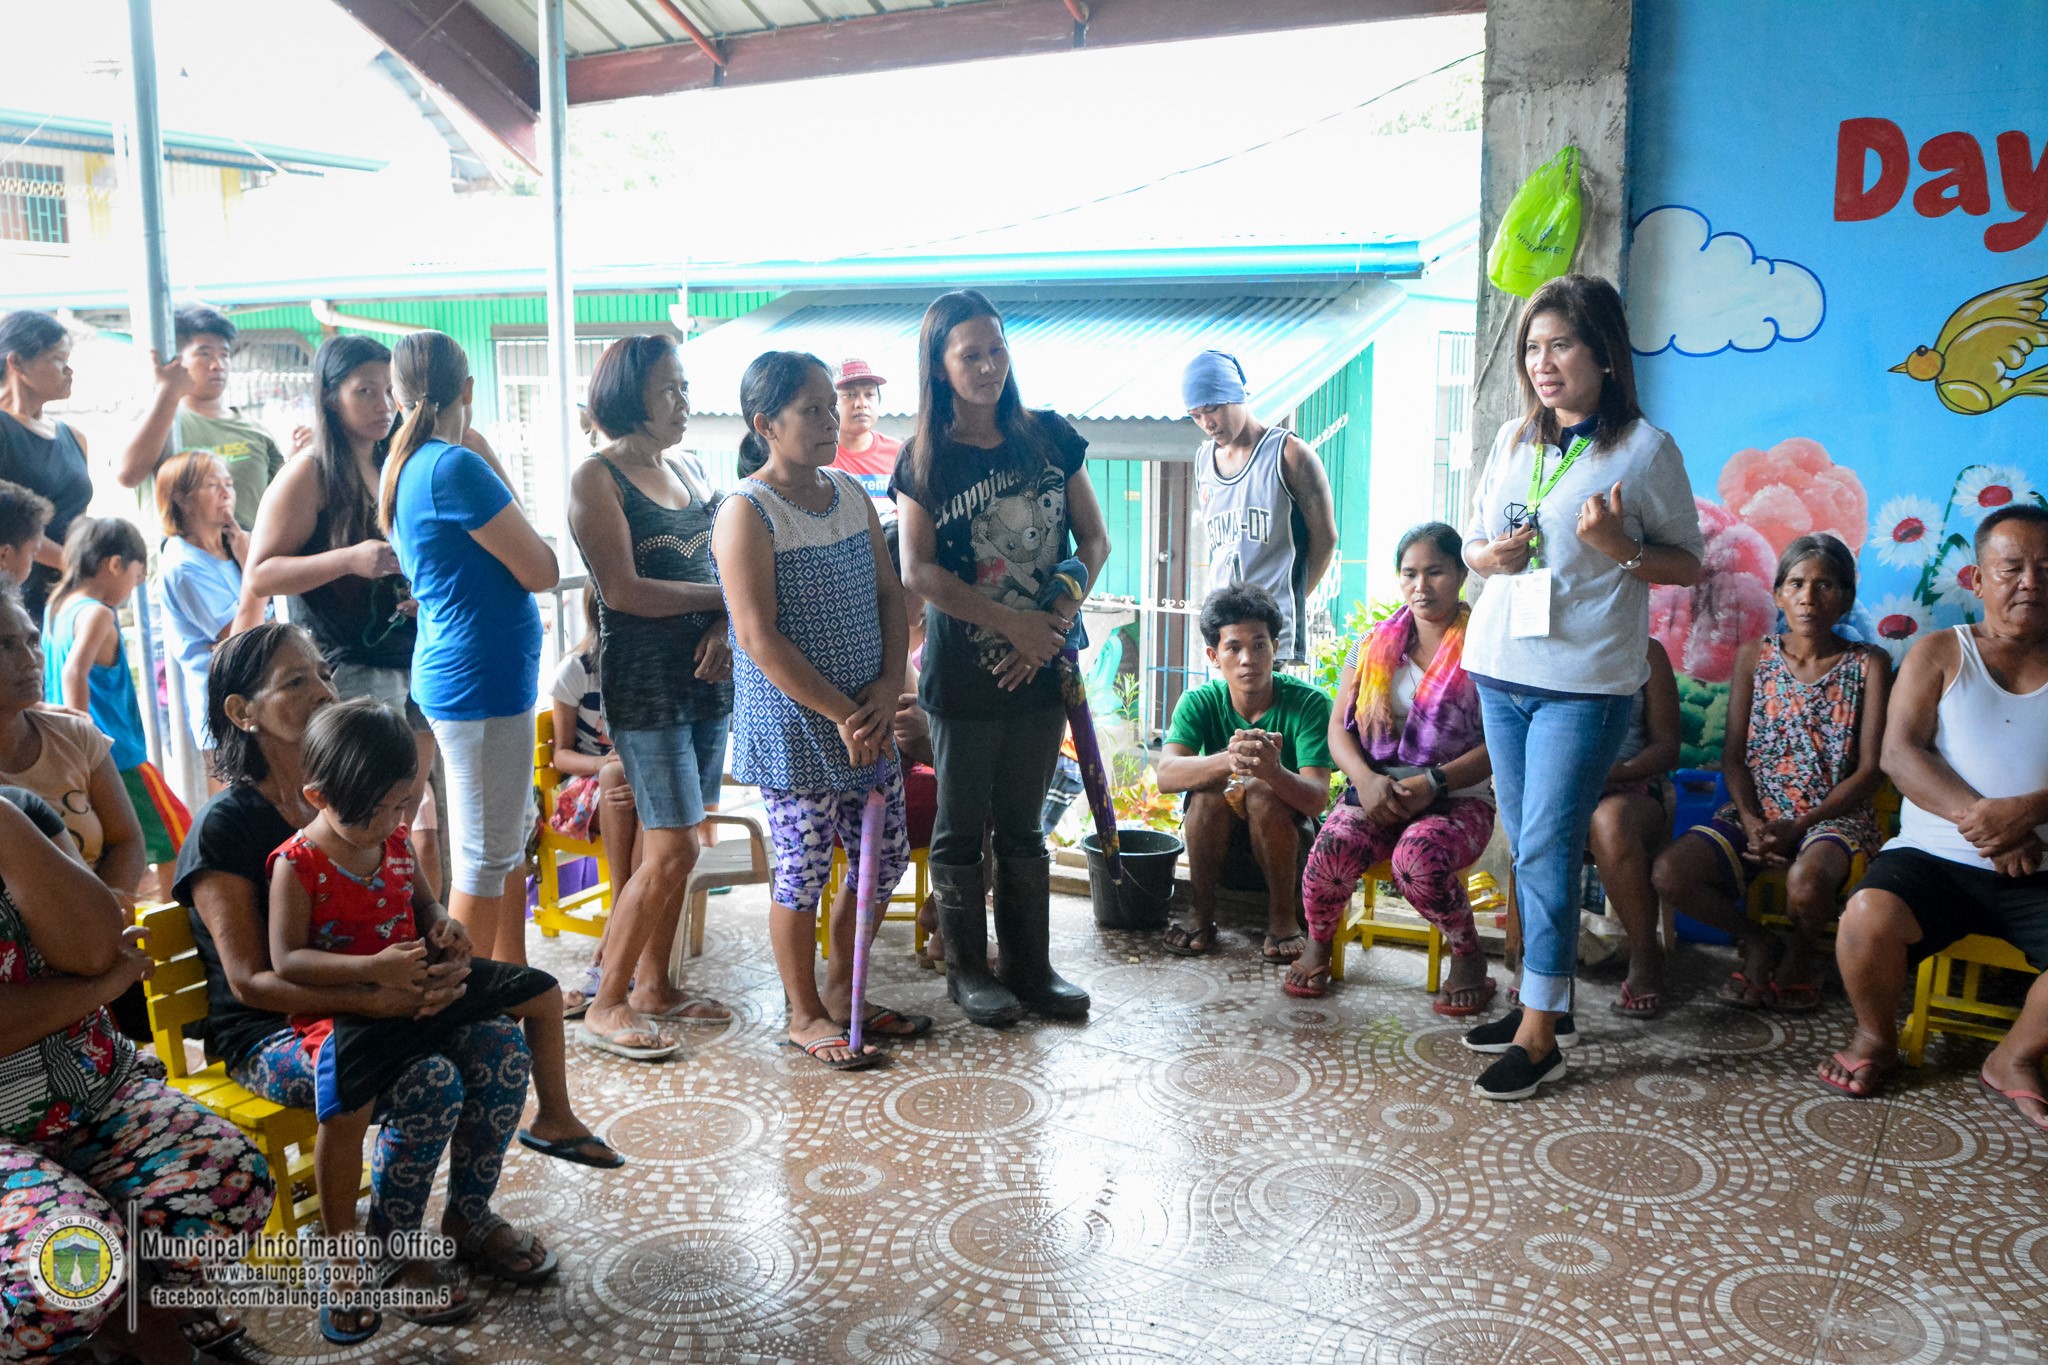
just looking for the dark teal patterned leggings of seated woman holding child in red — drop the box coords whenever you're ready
[233,1019,532,1236]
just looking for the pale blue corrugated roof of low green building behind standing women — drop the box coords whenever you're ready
[682,280,1405,422]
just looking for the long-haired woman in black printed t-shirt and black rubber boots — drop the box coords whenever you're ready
[891,289,1110,1025]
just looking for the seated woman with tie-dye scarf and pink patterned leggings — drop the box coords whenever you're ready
[1280,522,1493,1017]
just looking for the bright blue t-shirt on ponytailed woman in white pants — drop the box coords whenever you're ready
[391,440,541,720]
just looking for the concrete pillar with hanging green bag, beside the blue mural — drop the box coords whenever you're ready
[1460,0,1634,499]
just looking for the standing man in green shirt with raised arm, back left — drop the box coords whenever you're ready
[117,305,292,530]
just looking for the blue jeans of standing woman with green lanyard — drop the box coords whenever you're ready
[1479,686,1634,1011]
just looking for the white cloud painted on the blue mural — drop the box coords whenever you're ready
[1628,205,1827,356]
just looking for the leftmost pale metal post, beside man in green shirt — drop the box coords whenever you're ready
[125,0,207,806]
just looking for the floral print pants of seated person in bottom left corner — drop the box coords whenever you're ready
[0,1074,274,1361]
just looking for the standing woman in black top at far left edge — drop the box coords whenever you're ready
[0,309,92,626]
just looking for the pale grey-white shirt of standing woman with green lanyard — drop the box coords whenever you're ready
[1464,417,1706,696]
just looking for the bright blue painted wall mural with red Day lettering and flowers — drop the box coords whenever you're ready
[1624,0,2048,765]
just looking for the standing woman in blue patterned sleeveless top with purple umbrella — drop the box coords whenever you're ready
[711,350,932,1070]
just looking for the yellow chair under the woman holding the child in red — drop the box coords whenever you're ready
[139,905,369,1238]
